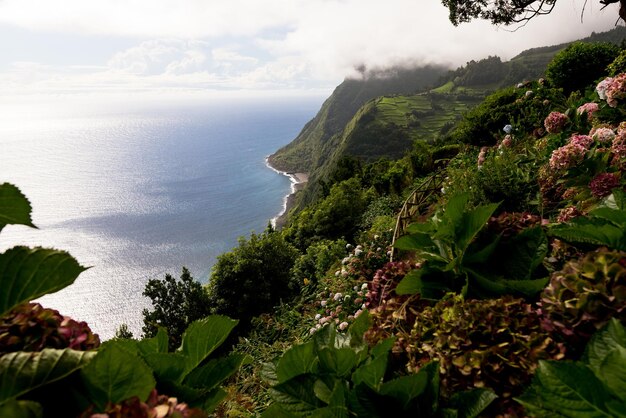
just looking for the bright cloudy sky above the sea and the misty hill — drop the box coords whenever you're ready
[0,0,623,97]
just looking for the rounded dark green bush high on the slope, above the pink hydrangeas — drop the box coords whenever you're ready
[546,42,619,95]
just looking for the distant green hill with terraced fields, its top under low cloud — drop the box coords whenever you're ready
[269,27,626,211]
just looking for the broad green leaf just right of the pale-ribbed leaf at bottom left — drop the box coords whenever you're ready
[81,345,156,410]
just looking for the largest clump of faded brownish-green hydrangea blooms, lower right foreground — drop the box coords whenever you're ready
[408,295,565,398]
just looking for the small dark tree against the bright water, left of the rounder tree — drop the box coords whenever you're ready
[142,267,210,350]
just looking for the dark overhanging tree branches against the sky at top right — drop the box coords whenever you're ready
[442,0,626,26]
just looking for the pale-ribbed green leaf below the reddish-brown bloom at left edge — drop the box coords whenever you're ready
[0,348,96,404]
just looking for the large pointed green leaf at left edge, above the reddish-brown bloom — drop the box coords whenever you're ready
[0,247,85,316]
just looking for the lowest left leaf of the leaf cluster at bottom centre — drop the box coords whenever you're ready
[269,374,324,415]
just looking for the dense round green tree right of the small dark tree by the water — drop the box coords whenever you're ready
[207,231,300,329]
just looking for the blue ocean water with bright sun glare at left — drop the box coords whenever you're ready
[0,97,322,339]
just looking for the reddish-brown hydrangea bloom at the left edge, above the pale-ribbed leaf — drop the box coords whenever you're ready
[0,303,100,355]
